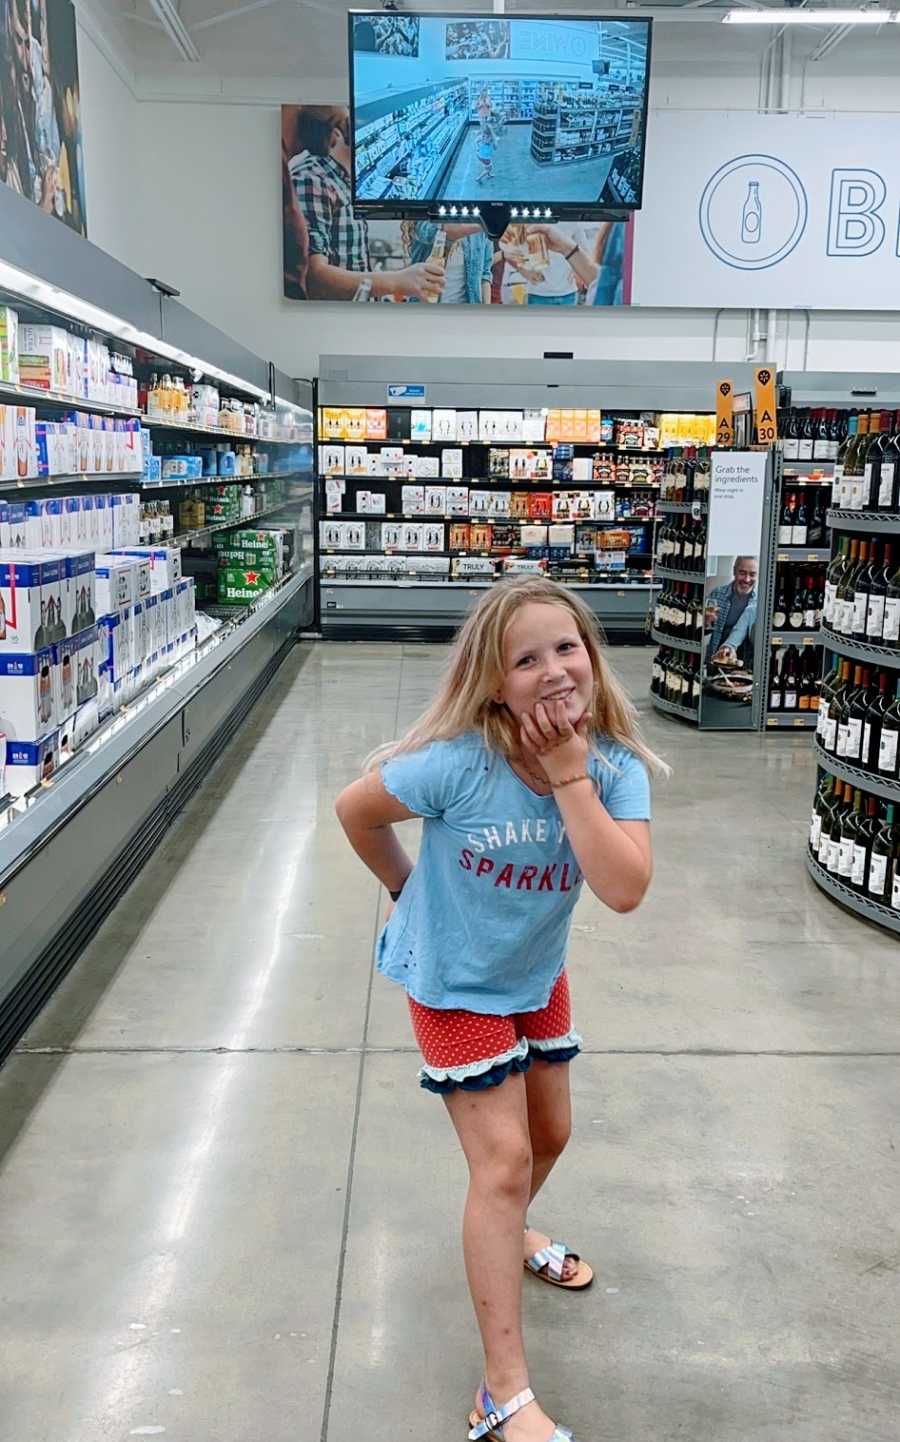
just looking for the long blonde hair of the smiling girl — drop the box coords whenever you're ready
[365,575,669,774]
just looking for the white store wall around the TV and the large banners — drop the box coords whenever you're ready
[70,25,900,379]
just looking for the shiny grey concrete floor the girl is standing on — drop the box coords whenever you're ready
[0,645,900,1442]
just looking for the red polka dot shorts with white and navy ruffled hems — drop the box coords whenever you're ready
[407,972,581,1094]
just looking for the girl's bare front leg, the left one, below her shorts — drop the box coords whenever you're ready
[446,1074,554,1442]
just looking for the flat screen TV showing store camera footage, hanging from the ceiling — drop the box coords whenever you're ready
[349,10,650,215]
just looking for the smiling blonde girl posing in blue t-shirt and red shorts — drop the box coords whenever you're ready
[336,577,662,1442]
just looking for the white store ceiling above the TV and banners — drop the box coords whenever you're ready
[98,0,900,86]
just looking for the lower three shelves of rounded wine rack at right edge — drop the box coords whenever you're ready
[806,508,900,933]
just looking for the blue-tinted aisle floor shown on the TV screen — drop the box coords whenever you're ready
[441,124,613,200]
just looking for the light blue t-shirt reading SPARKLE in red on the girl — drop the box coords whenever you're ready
[376,731,650,1017]
